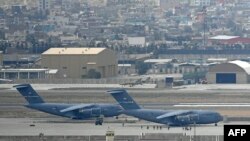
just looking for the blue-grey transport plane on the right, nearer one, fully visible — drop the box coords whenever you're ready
[108,89,223,128]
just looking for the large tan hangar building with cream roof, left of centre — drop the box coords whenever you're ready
[41,48,118,78]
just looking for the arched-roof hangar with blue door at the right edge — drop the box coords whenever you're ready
[207,60,250,84]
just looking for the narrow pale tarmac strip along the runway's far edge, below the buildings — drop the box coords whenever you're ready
[0,84,250,91]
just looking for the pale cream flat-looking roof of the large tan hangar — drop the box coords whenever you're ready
[42,47,106,55]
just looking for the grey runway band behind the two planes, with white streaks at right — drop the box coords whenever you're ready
[0,84,250,119]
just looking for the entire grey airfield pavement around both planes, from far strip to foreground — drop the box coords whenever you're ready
[0,84,250,139]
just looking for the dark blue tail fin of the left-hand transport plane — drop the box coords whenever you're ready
[14,84,44,104]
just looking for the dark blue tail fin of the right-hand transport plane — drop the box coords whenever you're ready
[108,89,140,110]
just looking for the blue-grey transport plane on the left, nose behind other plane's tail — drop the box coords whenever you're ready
[14,84,122,125]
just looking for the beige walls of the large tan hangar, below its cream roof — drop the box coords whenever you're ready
[41,49,118,78]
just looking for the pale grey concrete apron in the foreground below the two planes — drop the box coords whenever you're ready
[0,118,227,136]
